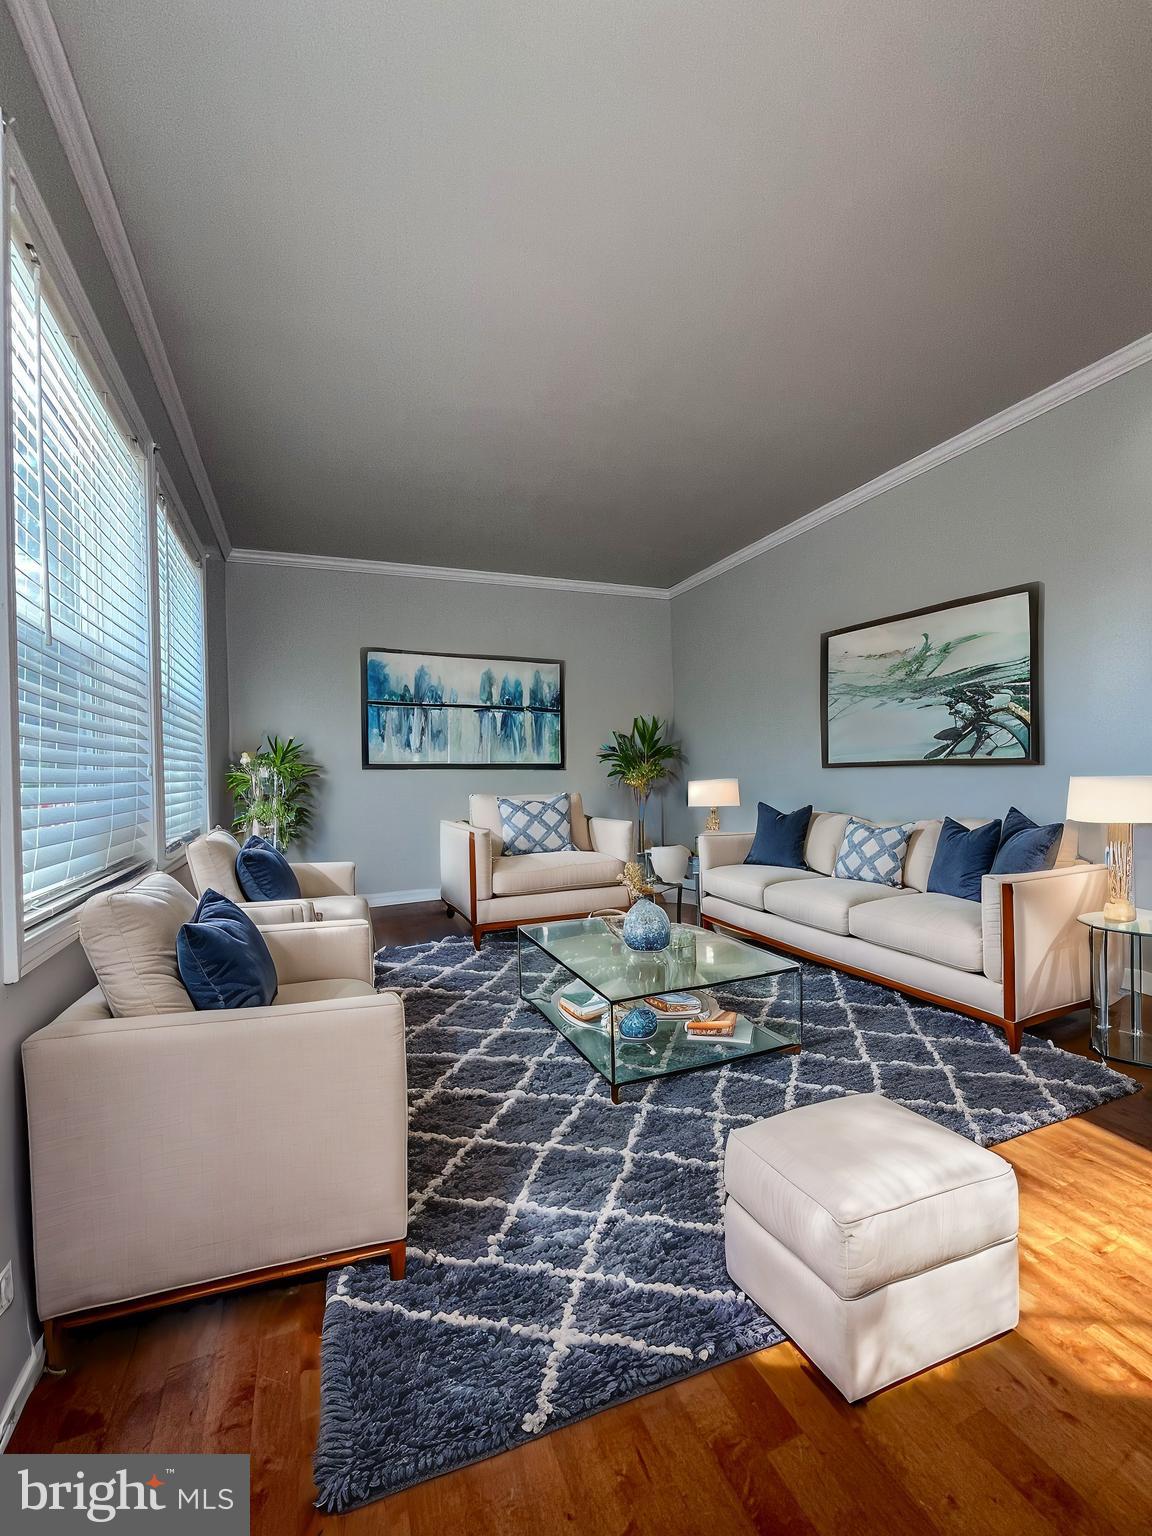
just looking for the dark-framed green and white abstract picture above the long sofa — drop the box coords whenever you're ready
[820,582,1043,768]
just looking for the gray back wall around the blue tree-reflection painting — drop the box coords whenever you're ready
[227,564,671,894]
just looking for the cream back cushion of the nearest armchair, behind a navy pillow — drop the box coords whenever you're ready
[80,871,197,1018]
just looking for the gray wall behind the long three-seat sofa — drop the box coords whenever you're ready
[673,367,1152,899]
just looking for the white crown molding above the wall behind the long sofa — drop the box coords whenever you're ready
[668,335,1152,598]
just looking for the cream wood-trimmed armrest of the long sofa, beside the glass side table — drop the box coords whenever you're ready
[980,863,1107,1020]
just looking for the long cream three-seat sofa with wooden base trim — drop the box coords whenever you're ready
[699,811,1107,1051]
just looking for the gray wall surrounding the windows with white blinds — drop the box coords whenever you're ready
[0,6,227,1428]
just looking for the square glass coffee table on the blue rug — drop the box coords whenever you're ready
[516,917,802,1104]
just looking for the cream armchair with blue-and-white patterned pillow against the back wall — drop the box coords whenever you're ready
[439,790,634,949]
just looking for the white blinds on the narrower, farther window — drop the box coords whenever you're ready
[157,490,207,852]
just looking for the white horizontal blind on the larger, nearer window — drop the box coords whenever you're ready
[9,215,152,929]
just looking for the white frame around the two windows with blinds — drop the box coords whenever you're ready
[0,125,212,985]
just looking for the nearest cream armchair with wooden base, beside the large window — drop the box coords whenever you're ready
[23,909,407,1364]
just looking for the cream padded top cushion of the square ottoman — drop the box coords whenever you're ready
[723,1094,1018,1298]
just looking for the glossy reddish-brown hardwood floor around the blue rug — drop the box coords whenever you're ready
[11,906,1152,1536]
